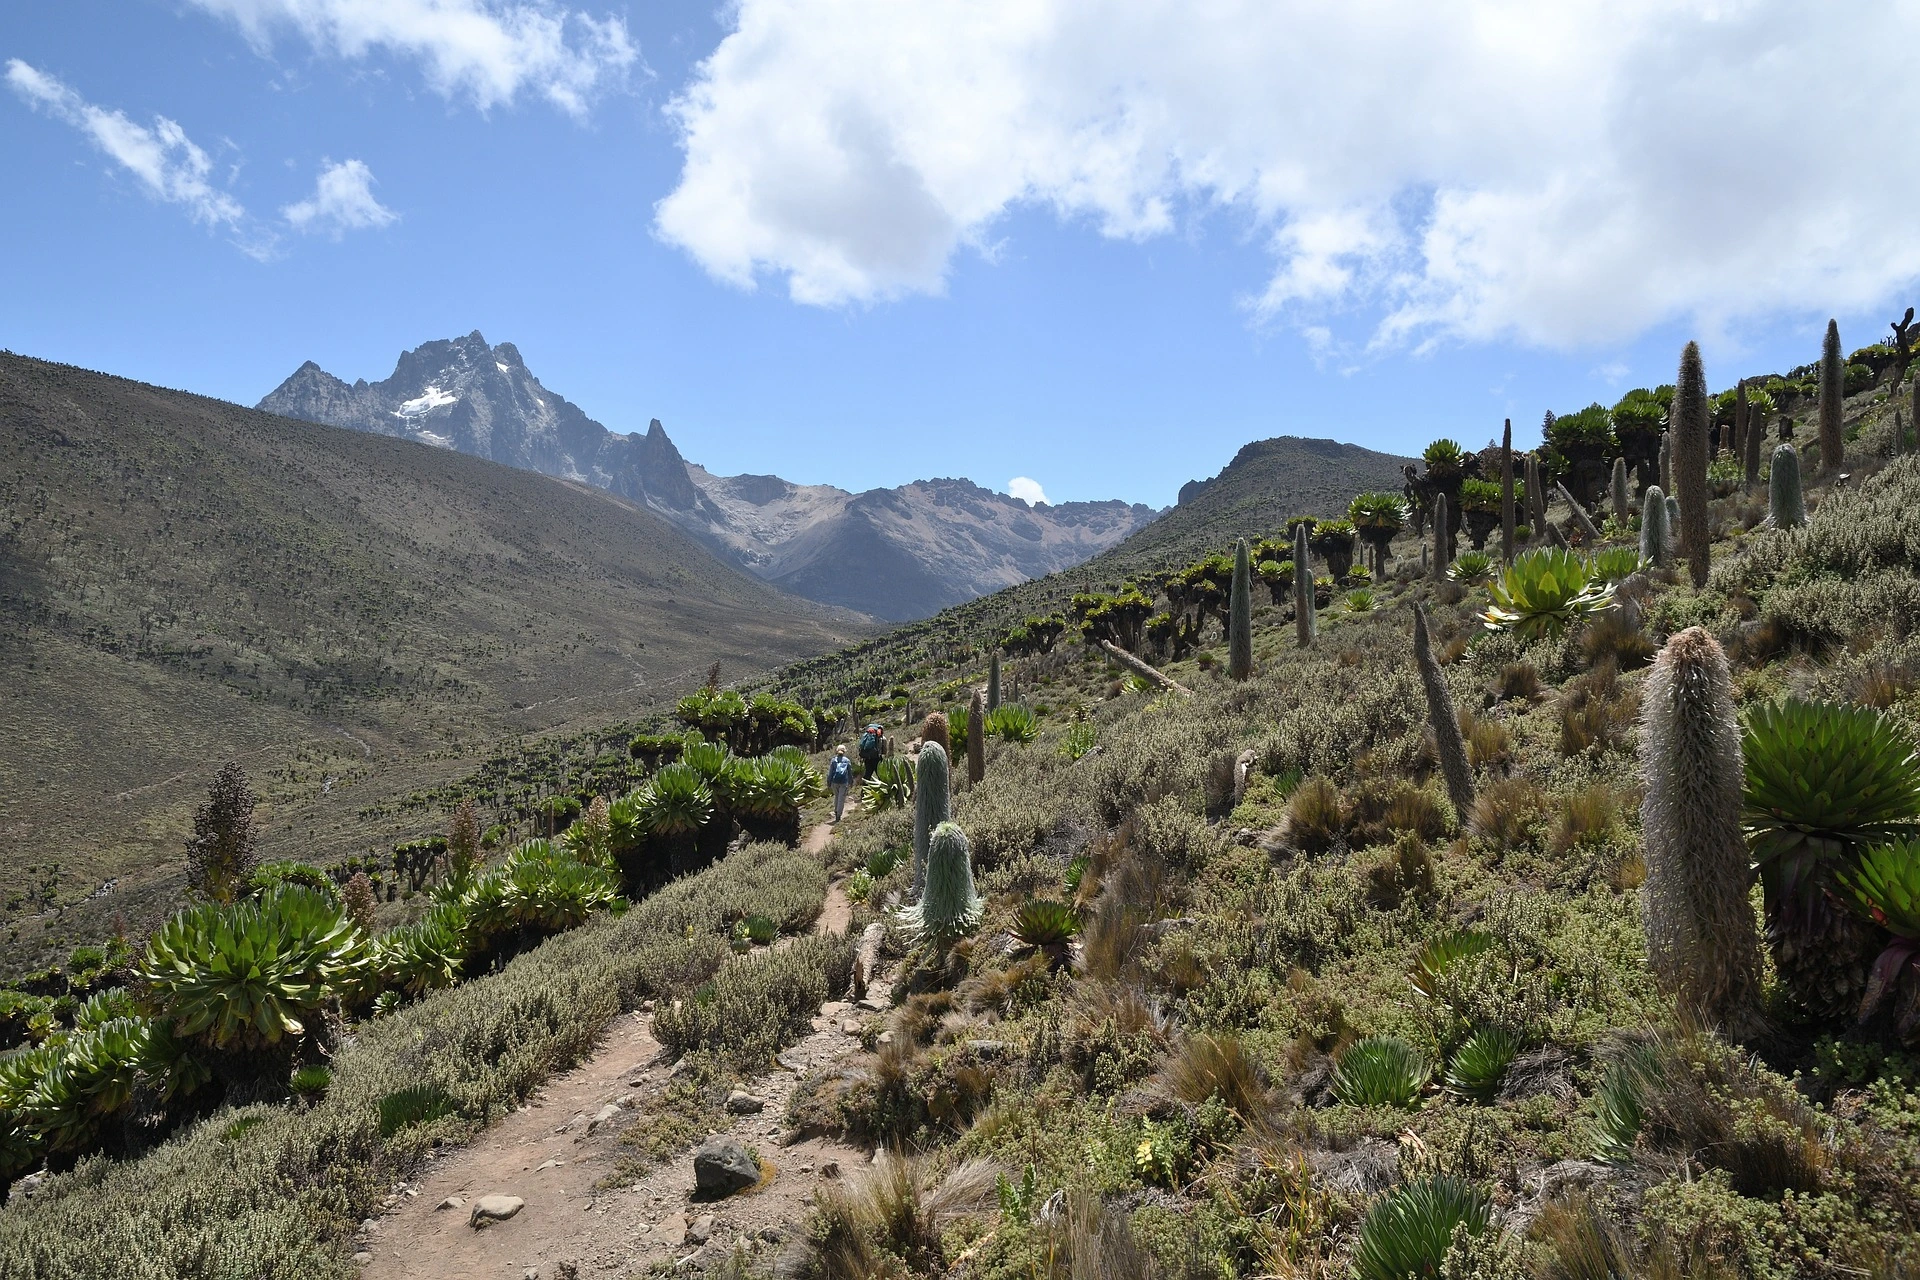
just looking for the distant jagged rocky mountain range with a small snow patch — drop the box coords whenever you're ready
[259,332,1156,622]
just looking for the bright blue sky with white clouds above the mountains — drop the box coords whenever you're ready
[0,0,1920,505]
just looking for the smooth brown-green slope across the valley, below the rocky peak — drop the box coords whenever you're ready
[0,355,862,967]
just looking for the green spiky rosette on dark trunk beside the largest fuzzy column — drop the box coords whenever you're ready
[1741,700,1920,1019]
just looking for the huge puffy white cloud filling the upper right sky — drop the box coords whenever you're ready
[656,0,1920,347]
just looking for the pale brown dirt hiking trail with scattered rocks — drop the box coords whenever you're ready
[355,825,871,1280]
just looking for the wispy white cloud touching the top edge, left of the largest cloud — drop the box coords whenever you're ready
[192,0,639,117]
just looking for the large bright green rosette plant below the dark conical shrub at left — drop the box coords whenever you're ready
[134,885,367,1048]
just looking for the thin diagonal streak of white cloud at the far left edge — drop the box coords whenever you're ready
[6,58,255,238]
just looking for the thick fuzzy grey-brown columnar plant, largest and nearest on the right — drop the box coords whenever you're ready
[1640,628,1761,1036]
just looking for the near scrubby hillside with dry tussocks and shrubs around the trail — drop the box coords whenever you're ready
[0,347,1920,1280]
